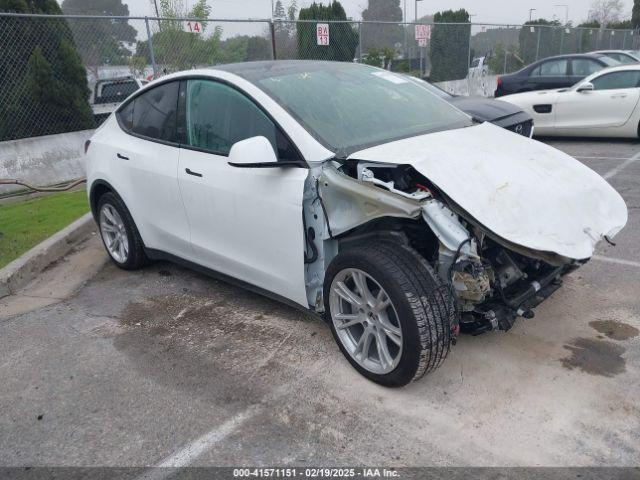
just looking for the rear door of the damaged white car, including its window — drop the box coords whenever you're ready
[110,81,191,256]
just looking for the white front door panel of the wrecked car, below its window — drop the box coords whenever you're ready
[176,149,309,307]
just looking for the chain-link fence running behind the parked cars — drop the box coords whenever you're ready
[0,13,640,141]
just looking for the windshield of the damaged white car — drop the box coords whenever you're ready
[238,62,472,156]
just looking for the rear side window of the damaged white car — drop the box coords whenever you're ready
[118,82,179,143]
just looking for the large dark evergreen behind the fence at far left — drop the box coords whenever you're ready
[0,0,94,140]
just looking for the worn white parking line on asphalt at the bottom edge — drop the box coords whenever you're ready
[136,405,260,480]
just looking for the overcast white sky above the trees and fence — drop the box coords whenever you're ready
[123,0,633,24]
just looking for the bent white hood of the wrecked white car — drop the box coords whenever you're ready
[349,123,627,260]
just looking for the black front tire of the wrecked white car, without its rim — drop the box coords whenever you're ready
[324,241,458,387]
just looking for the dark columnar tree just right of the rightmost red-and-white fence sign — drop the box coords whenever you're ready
[429,9,471,82]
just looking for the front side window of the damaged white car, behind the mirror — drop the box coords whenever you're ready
[186,80,299,160]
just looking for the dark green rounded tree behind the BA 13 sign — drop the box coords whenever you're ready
[298,0,358,62]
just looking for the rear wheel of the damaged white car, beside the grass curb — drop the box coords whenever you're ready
[98,192,147,270]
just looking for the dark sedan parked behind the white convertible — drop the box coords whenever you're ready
[495,53,619,98]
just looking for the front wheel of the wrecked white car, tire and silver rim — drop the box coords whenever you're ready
[324,242,457,387]
